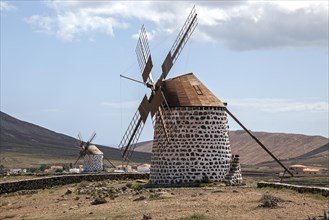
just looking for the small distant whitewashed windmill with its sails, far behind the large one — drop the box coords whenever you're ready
[74,132,104,172]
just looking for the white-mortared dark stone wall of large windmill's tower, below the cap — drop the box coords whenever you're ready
[150,107,231,184]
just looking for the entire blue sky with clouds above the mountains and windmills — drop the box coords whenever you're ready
[0,0,329,146]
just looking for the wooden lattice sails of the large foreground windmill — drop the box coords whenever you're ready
[119,7,198,162]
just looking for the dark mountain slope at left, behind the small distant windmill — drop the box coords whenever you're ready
[0,111,151,167]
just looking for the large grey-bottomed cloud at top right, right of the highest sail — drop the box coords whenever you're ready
[196,1,328,50]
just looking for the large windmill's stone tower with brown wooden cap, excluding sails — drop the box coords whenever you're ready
[150,73,242,184]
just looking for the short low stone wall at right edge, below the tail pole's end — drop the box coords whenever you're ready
[257,181,329,197]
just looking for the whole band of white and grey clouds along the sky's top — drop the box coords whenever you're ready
[24,0,328,50]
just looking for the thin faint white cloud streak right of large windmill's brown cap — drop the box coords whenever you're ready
[229,98,329,113]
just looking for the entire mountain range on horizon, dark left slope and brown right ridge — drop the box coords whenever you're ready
[0,112,329,167]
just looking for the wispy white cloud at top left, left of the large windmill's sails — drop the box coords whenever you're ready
[26,1,128,41]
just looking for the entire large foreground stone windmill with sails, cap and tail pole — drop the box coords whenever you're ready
[119,7,288,185]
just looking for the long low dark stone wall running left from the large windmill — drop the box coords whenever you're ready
[0,173,149,194]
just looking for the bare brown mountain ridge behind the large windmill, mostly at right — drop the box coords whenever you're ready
[136,130,329,165]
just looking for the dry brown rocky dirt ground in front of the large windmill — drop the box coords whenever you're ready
[0,178,329,220]
